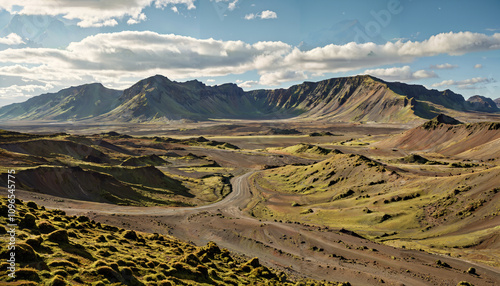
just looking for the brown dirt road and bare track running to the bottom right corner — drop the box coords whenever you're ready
[19,171,500,285]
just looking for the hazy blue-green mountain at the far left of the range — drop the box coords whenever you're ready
[0,83,122,121]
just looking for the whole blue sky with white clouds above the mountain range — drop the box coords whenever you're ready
[0,0,500,106]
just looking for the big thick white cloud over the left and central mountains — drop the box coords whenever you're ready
[0,31,291,86]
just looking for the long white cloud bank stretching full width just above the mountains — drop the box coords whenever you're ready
[0,31,500,93]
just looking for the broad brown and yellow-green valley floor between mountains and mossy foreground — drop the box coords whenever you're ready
[0,121,500,285]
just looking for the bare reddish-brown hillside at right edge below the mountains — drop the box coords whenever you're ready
[375,115,500,160]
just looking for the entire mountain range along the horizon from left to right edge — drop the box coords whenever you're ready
[0,75,500,123]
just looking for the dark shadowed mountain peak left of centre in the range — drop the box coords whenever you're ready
[95,75,264,122]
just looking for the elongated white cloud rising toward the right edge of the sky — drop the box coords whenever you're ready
[277,32,500,76]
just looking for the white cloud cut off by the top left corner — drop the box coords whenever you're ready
[0,0,196,28]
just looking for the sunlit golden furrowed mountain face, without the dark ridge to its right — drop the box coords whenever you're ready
[251,76,418,122]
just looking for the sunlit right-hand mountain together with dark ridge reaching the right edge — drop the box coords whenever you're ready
[249,75,498,122]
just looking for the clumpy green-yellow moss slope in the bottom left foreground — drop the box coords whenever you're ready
[0,197,337,285]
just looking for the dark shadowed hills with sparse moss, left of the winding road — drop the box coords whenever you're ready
[0,130,238,206]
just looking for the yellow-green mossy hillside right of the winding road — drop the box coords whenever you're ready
[251,147,500,268]
